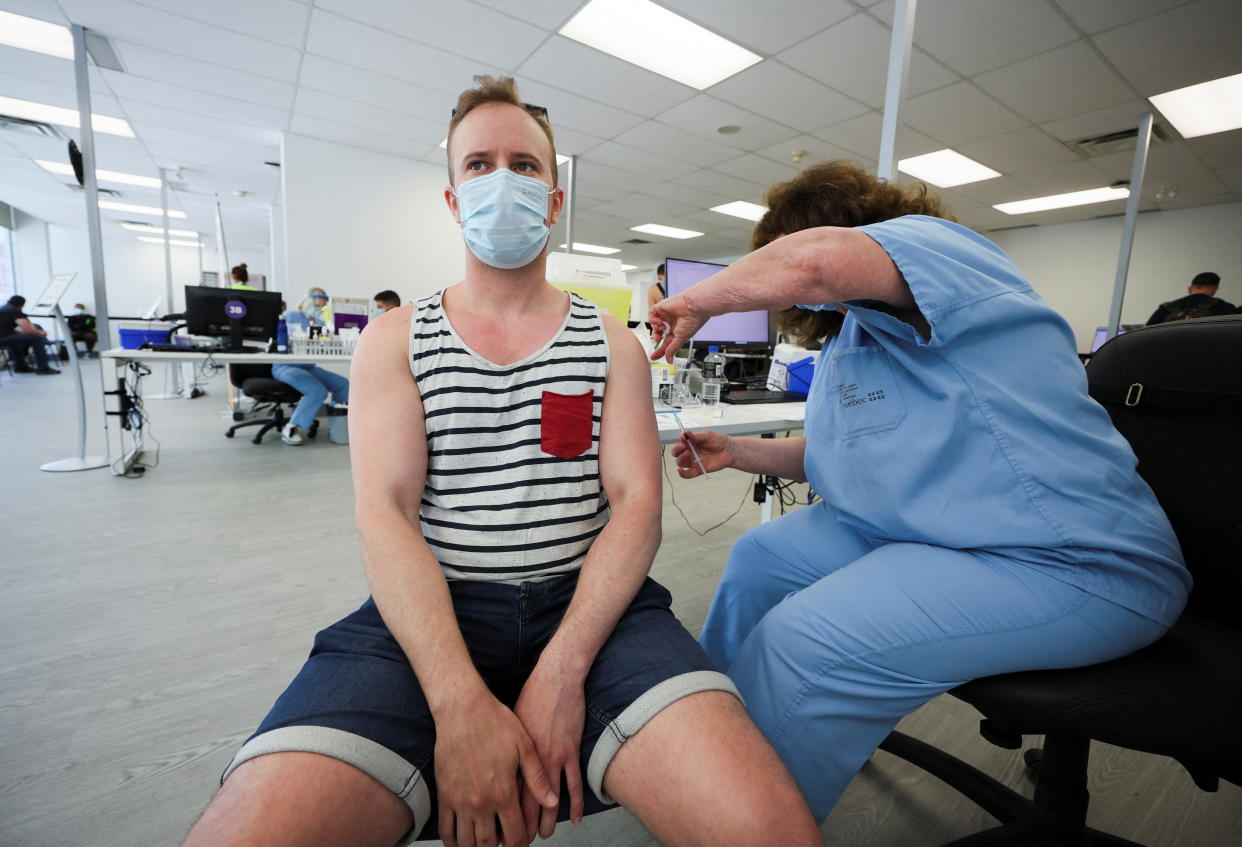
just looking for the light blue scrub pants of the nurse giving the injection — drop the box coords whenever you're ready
[699,502,1167,821]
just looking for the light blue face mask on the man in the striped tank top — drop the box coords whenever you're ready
[453,168,555,271]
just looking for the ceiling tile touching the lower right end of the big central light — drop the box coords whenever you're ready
[710,61,869,132]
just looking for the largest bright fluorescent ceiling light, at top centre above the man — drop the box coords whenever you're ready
[560,0,763,91]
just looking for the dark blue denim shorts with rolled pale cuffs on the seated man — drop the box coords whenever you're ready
[220,573,738,840]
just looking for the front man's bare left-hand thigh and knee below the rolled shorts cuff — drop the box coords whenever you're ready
[185,753,414,847]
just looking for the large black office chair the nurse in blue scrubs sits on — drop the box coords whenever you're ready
[881,315,1242,847]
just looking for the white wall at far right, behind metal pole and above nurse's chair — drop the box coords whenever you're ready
[987,202,1242,351]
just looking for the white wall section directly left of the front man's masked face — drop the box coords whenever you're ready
[281,133,466,306]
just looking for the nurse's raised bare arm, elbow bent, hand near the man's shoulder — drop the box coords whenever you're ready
[650,226,915,360]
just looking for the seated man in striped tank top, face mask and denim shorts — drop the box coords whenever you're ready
[188,77,821,847]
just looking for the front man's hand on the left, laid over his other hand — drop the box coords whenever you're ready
[436,694,556,847]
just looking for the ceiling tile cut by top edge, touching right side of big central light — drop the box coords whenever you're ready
[661,0,854,55]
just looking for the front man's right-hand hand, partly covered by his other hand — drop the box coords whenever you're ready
[513,666,586,838]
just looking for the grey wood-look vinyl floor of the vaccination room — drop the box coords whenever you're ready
[0,363,1242,847]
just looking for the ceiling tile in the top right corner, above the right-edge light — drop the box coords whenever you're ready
[1094,0,1242,97]
